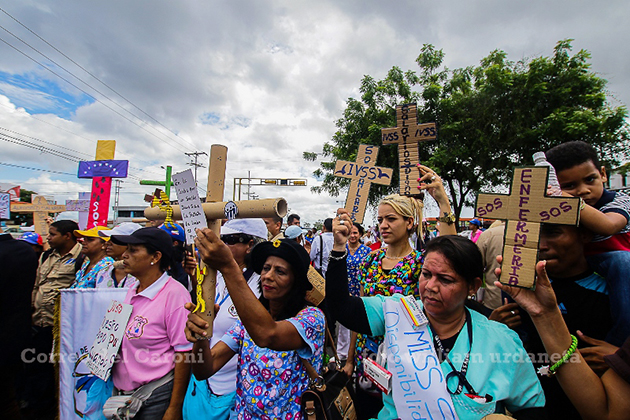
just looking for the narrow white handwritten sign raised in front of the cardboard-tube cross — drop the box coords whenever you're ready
[173,169,208,244]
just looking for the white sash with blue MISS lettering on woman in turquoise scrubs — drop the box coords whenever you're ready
[383,299,458,420]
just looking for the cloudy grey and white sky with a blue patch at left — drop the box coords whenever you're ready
[0,0,630,224]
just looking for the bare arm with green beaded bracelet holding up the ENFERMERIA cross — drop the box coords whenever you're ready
[495,261,630,419]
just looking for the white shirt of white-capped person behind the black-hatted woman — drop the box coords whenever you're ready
[208,273,260,395]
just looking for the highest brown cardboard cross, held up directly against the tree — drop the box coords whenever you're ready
[381,104,437,195]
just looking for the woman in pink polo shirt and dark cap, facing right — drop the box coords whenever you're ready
[106,227,192,419]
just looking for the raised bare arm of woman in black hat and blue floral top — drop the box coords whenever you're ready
[195,229,306,351]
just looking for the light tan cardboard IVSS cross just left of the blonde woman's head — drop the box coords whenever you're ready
[334,144,394,223]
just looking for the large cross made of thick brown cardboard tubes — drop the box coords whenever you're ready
[144,144,287,336]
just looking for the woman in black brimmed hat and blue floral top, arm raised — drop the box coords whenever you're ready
[186,229,325,419]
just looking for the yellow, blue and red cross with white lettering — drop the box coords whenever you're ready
[78,140,129,229]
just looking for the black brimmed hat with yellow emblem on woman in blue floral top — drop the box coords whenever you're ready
[250,239,313,290]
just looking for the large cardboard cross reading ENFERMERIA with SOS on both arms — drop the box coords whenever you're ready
[475,166,580,289]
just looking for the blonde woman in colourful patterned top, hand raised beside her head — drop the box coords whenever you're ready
[345,165,456,418]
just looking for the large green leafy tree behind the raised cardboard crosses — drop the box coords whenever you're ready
[304,40,630,223]
